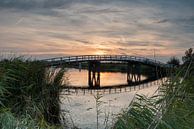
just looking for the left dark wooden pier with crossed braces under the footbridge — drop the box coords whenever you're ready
[88,61,100,88]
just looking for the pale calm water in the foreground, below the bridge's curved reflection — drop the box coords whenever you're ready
[61,80,160,129]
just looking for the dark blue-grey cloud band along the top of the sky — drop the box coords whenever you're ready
[0,0,194,12]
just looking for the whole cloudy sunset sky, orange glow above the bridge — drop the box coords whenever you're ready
[0,0,194,62]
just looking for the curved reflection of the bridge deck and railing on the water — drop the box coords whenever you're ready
[62,77,166,95]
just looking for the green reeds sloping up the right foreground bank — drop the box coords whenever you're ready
[114,62,194,129]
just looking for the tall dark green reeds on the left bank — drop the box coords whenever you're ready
[0,58,64,129]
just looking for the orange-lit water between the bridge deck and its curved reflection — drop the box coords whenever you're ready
[65,68,146,87]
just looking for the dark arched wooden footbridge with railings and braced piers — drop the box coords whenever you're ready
[42,55,170,89]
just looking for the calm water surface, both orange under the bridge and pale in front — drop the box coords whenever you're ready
[60,68,164,129]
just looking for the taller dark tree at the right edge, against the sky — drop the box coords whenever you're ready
[182,48,194,64]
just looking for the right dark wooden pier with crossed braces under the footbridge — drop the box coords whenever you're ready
[127,62,141,85]
